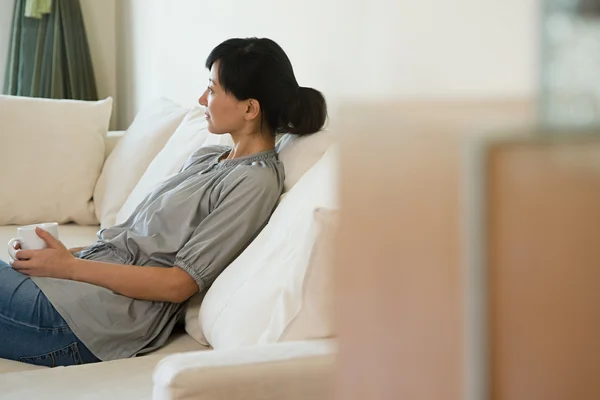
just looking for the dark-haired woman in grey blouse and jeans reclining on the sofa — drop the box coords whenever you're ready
[0,38,326,366]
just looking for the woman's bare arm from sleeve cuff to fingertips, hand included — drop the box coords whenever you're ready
[12,229,199,303]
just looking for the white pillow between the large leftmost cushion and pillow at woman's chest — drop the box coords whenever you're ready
[94,98,188,228]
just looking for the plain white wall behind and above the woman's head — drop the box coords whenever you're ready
[118,0,539,128]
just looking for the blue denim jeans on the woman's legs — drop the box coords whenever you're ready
[0,260,100,367]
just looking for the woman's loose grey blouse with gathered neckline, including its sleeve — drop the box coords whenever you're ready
[32,146,284,361]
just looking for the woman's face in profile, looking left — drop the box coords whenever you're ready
[198,61,247,134]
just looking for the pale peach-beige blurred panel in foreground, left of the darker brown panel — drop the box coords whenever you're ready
[336,100,534,400]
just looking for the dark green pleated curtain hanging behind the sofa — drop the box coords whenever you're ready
[4,0,98,100]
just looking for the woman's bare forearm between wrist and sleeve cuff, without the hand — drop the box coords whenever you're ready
[68,258,199,303]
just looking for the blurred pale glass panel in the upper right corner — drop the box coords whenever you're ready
[540,0,600,127]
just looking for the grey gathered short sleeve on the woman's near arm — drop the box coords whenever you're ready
[175,173,280,291]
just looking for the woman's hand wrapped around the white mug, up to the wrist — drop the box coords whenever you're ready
[11,228,76,279]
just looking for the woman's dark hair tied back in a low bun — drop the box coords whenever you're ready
[206,38,327,135]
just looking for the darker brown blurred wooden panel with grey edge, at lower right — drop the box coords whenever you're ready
[469,132,600,400]
